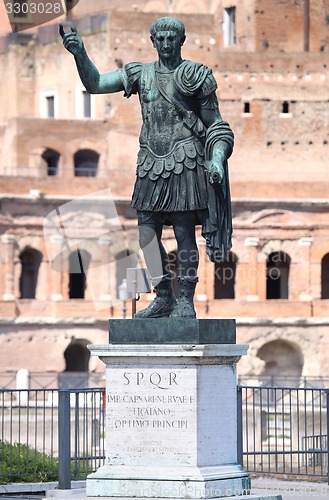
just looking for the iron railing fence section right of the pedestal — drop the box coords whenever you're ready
[238,386,329,479]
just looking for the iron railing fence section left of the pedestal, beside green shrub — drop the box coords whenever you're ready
[0,388,105,484]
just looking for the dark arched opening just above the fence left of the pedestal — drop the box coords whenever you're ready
[59,339,90,389]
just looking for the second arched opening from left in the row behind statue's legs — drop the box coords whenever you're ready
[69,250,91,299]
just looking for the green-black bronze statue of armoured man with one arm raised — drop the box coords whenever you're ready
[60,17,234,318]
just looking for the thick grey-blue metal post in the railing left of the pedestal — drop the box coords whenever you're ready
[58,390,71,490]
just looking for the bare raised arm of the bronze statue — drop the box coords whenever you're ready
[59,24,124,94]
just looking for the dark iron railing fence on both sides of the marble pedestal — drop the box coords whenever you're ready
[0,386,329,488]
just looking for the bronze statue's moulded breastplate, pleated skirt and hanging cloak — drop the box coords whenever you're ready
[119,61,234,262]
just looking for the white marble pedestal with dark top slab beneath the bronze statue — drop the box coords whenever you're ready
[87,320,280,499]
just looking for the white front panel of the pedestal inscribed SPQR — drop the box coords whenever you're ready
[106,365,197,465]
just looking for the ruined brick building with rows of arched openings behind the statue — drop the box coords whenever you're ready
[0,0,329,387]
